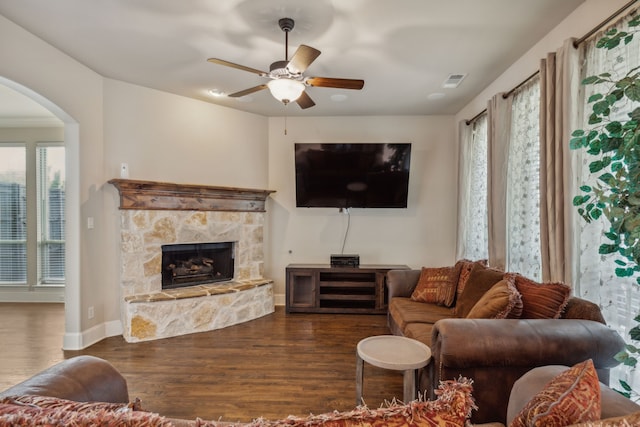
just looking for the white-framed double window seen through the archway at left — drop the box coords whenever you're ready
[0,142,65,288]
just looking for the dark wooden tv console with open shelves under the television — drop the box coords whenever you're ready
[286,264,409,314]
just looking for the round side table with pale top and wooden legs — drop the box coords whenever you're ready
[356,335,431,405]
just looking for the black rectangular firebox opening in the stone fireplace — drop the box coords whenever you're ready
[162,242,234,289]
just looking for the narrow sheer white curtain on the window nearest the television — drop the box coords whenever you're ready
[456,114,488,260]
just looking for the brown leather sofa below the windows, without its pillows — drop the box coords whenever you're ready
[387,270,624,423]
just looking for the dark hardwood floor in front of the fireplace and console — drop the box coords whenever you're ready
[0,304,402,421]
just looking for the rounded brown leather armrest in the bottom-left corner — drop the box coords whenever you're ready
[0,355,129,403]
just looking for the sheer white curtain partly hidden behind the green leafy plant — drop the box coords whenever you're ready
[574,15,640,392]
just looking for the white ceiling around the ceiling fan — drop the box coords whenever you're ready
[0,0,584,116]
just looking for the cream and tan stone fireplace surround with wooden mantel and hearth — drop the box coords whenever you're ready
[109,179,274,342]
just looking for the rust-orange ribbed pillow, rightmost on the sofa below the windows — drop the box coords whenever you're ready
[507,273,571,319]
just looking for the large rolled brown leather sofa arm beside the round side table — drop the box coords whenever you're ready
[428,319,624,423]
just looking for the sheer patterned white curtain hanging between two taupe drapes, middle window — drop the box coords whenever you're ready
[506,77,541,280]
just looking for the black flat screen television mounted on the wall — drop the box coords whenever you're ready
[295,143,411,208]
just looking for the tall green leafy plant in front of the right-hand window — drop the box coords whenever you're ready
[570,18,640,397]
